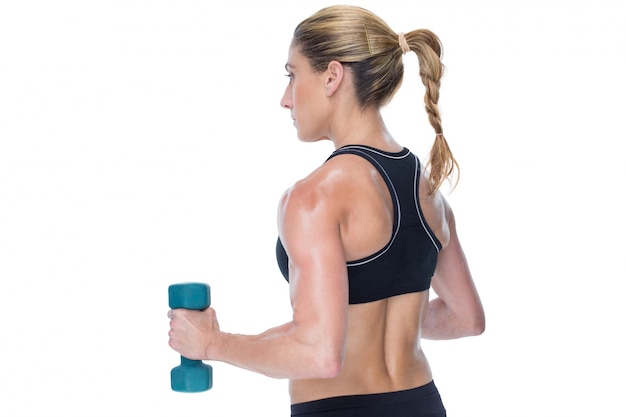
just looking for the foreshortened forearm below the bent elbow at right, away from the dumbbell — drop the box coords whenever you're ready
[421,298,484,340]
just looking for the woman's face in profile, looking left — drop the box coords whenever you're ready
[280,44,329,142]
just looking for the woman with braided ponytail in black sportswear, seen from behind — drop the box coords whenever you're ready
[169,6,485,417]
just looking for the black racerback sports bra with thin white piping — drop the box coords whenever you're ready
[276,145,441,304]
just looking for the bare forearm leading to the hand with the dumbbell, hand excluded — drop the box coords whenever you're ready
[210,322,337,379]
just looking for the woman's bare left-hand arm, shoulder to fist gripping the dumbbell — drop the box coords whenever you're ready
[170,174,348,379]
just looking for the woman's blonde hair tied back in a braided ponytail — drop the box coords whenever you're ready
[293,6,459,193]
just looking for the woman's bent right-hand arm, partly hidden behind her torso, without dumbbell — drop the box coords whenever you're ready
[422,203,485,339]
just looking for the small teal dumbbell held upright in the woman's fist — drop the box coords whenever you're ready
[168,282,213,392]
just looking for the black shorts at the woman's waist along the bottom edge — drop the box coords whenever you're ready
[291,382,446,417]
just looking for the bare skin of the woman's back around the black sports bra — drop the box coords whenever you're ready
[280,143,448,404]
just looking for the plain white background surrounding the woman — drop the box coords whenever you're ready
[0,0,626,417]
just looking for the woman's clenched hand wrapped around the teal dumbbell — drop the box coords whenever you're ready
[167,307,220,360]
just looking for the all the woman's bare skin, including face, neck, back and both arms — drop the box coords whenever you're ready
[169,45,485,403]
